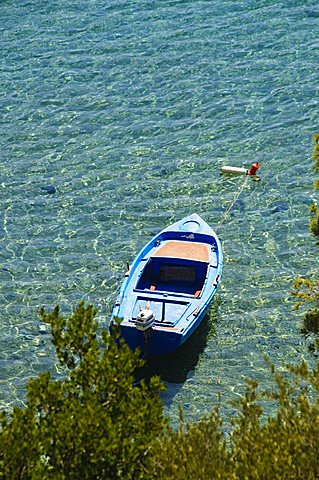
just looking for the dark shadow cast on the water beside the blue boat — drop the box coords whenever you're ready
[137,296,220,384]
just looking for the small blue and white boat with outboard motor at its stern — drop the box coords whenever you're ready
[111,213,223,355]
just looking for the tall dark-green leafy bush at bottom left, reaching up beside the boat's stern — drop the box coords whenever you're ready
[0,302,166,480]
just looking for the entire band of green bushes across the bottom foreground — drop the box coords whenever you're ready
[0,303,319,480]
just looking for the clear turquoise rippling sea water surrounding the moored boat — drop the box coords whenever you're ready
[0,0,319,422]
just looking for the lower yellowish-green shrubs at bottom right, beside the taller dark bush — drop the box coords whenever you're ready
[148,363,319,480]
